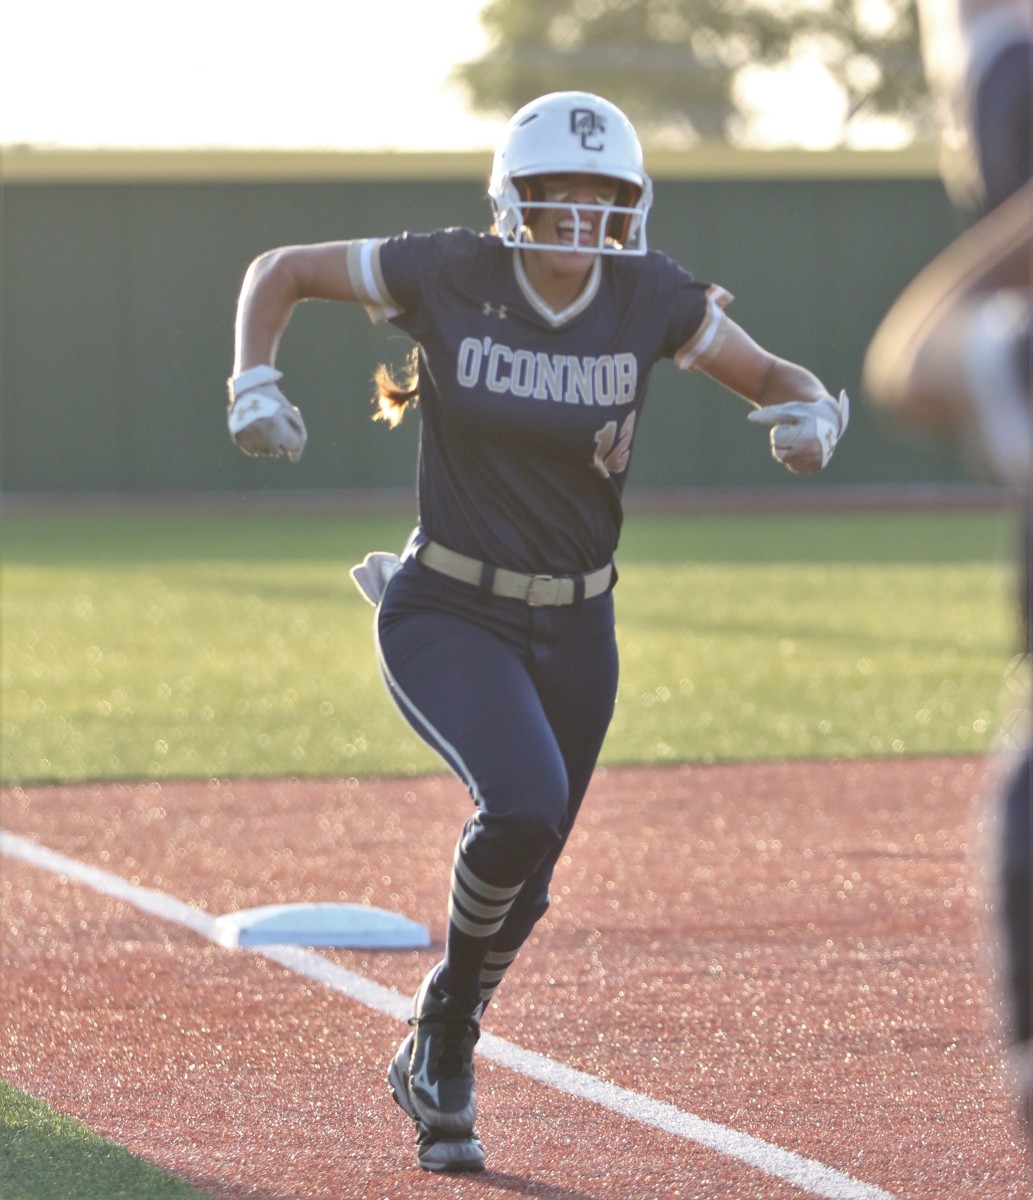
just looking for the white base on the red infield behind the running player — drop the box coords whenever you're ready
[215,904,431,949]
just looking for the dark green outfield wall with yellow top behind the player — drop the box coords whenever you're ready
[0,150,965,496]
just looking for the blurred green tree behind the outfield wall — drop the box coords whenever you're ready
[455,0,930,145]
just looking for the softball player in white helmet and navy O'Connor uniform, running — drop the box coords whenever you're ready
[229,92,848,1171]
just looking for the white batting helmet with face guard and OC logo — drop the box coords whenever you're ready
[488,91,653,254]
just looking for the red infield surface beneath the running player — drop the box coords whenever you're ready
[0,758,1031,1200]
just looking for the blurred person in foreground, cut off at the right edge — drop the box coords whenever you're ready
[865,0,1033,1142]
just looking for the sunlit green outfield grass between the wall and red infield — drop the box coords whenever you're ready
[0,512,1016,782]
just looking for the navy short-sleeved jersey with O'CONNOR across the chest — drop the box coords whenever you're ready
[349,229,731,575]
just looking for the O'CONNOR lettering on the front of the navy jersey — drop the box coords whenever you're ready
[456,337,638,408]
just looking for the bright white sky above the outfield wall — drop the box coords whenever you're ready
[0,0,911,150]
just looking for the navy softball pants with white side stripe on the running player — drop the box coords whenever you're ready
[377,559,618,1009]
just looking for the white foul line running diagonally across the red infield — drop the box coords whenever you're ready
[0,829,896,1200]
